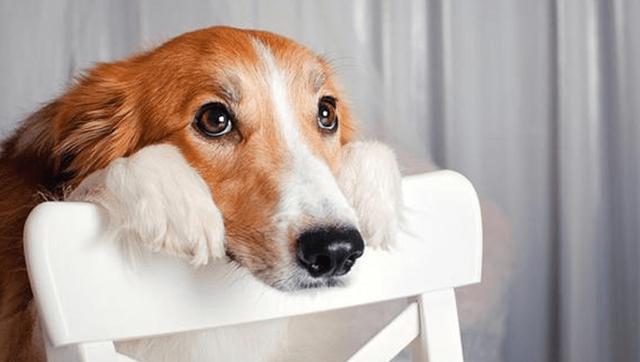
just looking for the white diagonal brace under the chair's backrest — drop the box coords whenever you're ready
[349,302,420,362]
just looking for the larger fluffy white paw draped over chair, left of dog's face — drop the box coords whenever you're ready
[67,145,224,265]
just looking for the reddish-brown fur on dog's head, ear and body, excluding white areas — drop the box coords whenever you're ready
[0,28,353,361]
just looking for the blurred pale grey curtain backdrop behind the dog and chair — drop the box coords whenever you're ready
[0,0,640,362]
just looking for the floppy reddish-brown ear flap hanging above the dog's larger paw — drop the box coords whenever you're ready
[51,64,141,188]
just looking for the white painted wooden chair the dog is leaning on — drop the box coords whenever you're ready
[25,171,482,362]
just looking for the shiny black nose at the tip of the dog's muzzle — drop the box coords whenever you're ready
[296,227,364,277]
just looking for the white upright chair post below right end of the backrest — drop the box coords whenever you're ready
[413,288,463,362]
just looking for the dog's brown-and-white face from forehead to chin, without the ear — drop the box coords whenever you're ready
[166,29,363,289]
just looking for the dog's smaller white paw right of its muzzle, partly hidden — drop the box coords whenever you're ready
[338,142,402,248]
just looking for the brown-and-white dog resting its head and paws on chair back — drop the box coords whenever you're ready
[0,27,401,361]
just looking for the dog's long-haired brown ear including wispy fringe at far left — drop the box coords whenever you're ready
[7,64,141,189]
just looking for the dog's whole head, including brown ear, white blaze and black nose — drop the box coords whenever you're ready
[17,27,364,289]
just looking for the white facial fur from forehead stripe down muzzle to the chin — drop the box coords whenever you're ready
[254,40,358,289]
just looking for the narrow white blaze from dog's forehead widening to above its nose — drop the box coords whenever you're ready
[255,41,357,239]
